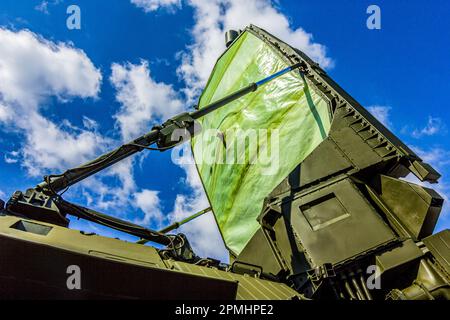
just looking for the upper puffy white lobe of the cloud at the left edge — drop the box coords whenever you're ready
[0,29,102,109]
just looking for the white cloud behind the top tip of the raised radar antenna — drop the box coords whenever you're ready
[178,0,333,101]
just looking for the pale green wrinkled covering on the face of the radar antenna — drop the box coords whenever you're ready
[192,30,331,255]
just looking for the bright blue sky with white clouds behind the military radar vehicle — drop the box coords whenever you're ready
[0,0,450,258]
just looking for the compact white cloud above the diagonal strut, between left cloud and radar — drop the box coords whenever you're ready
[110,61,183,140]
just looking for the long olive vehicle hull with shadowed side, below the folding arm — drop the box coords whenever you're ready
[0,213,300,300]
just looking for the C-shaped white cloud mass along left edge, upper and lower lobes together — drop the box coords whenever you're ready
[0,28,106,175]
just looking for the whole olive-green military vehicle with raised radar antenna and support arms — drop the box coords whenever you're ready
[0,26,450,300]
